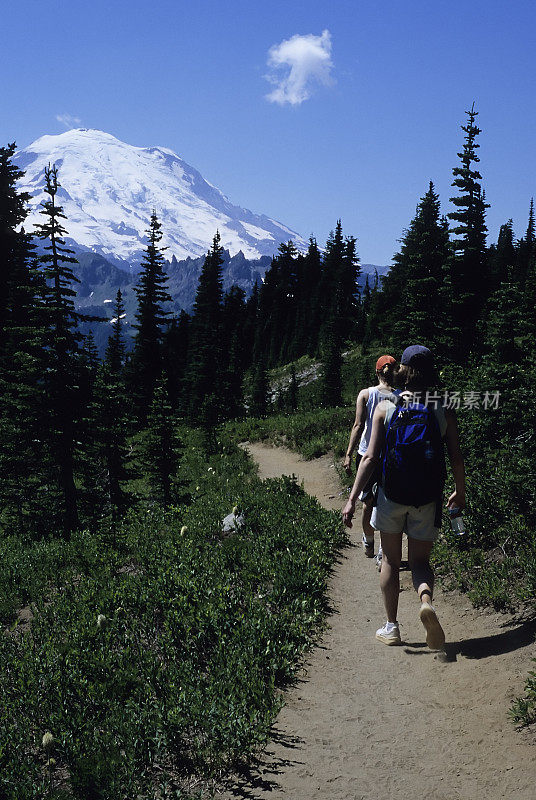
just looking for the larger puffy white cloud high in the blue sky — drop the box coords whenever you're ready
[266,30,333,106]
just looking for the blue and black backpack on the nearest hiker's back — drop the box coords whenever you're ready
[381,398,446,509]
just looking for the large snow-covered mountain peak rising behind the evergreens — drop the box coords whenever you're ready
[14,128,305,268]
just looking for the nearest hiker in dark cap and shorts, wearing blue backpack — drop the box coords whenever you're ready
[342,345,465,650]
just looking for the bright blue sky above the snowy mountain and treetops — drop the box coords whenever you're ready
[0,0,536,264]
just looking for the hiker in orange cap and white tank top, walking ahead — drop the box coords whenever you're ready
[343,355,396,566]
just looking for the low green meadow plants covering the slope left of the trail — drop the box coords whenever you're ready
[0,440,342,800]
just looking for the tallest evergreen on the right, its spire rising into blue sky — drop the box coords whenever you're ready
[448,104,489,358]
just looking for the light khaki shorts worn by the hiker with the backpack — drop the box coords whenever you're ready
[370,486,441,542]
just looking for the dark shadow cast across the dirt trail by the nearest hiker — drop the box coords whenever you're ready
[404,619,536,662]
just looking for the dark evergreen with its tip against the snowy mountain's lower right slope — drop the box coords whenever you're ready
[187,233,224,419]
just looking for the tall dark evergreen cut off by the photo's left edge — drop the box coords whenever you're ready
[0,144,52,535]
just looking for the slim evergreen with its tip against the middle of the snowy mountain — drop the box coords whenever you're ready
[132,211,172,420]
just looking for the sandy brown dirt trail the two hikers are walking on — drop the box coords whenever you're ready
[225,444,536,800]
